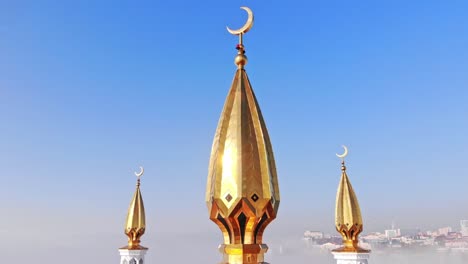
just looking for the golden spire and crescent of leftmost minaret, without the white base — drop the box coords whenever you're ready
[125,167,146,249]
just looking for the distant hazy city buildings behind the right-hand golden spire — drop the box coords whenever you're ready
[304,220,468,253]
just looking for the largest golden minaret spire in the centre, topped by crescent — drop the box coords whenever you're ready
[206,7,280,264]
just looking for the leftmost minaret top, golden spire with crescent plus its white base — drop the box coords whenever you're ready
[119,167,148,264]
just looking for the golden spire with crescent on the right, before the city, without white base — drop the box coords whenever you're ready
[334,146,369,253]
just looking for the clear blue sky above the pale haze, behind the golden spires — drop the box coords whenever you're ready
[0,0,468,252]
